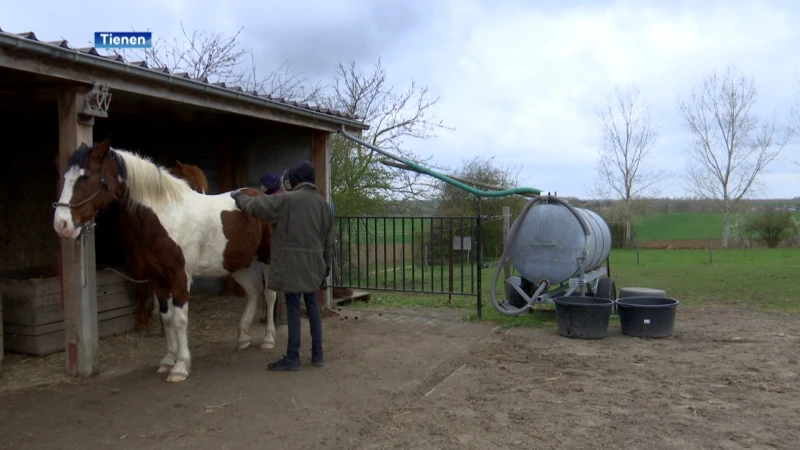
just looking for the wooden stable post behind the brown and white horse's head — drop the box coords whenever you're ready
[58,87,100,376]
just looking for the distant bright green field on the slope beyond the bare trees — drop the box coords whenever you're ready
[636,212,800,241]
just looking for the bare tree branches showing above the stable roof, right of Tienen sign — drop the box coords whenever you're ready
[110,24,323,102]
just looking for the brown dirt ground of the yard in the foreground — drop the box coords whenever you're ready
[0,299,800,450]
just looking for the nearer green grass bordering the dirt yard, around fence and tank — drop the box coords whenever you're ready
[346,249,800,327]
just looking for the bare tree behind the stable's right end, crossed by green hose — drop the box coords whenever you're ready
[322,60,452,214]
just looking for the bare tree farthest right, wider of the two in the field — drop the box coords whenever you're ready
[679,67,792,247]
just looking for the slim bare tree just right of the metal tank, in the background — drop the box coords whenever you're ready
[595,83,669,247]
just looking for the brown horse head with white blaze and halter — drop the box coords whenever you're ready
[53,138,125,239]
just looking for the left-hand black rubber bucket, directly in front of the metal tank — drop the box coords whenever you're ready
[553,296,614,339]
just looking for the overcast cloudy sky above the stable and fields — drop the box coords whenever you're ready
[6,0,800,197]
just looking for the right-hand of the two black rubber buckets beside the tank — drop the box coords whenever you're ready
[617,297,680,338]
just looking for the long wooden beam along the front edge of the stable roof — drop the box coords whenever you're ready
[0,51,357,133]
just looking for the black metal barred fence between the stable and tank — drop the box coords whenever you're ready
[333,217,482,300]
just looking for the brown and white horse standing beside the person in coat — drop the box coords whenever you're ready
[53,139,275,382]
